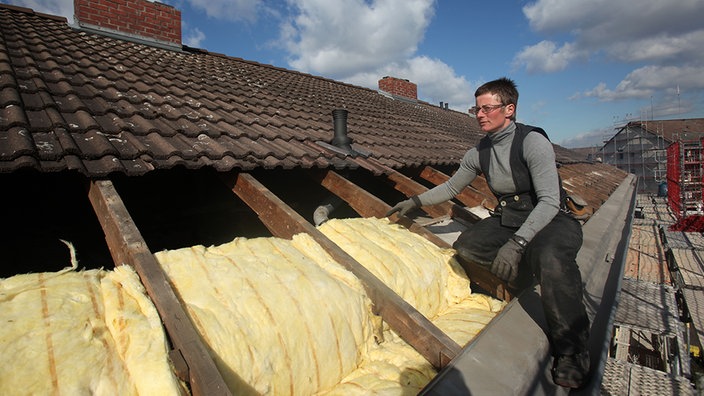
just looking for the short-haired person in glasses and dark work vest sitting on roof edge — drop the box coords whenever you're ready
[387,78,589,388]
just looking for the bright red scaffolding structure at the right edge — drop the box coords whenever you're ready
[667,140,704,232]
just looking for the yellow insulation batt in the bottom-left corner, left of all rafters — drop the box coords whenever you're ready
[0,266,181,396]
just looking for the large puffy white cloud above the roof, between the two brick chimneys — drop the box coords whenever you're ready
[281,0,474,111]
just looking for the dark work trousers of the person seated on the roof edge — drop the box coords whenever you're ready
[453,212,589,355]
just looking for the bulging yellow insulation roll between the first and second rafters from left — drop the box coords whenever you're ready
[156,229,374,395]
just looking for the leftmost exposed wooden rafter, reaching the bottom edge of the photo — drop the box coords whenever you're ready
[88,180,231,396]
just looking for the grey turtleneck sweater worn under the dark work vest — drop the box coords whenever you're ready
[418,122,560,241]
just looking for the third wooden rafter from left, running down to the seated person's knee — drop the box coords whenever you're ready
[320,171,513,301]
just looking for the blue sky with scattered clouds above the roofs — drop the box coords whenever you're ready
[5,0,704,147]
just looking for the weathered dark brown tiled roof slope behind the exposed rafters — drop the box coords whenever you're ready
[0,5,579,177]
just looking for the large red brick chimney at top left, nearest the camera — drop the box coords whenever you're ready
[73,0,181,48]
